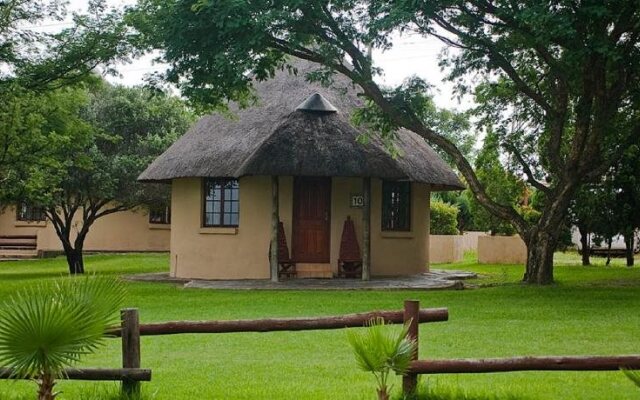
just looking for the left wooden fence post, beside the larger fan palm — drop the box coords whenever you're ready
[120,308,140,396]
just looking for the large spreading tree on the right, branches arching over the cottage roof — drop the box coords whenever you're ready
[129,0,640,284]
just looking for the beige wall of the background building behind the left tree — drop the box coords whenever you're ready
[0,206,171,252]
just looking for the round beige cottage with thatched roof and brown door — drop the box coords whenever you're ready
[139,63,462,280]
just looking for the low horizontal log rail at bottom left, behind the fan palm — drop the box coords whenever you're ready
[0,368,151,382]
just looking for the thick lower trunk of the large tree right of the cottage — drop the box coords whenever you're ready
[523,227,558,285]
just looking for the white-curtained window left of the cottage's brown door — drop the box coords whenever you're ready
[202,178,240,227]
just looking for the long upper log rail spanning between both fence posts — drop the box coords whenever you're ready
[109,308,449,336]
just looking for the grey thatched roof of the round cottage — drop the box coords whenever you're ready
[138,62,463,190]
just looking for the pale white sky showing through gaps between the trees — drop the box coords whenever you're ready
[55,0,472,110]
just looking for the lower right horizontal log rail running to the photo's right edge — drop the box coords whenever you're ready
[410,355,640,374]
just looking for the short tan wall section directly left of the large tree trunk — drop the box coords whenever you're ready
[478,236,527,264]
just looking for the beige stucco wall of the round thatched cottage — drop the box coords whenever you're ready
[171,176,429,279]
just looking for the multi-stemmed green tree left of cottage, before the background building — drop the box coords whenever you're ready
[23,83,193,274]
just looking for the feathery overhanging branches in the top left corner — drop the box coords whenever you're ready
[0,0,131,91]
